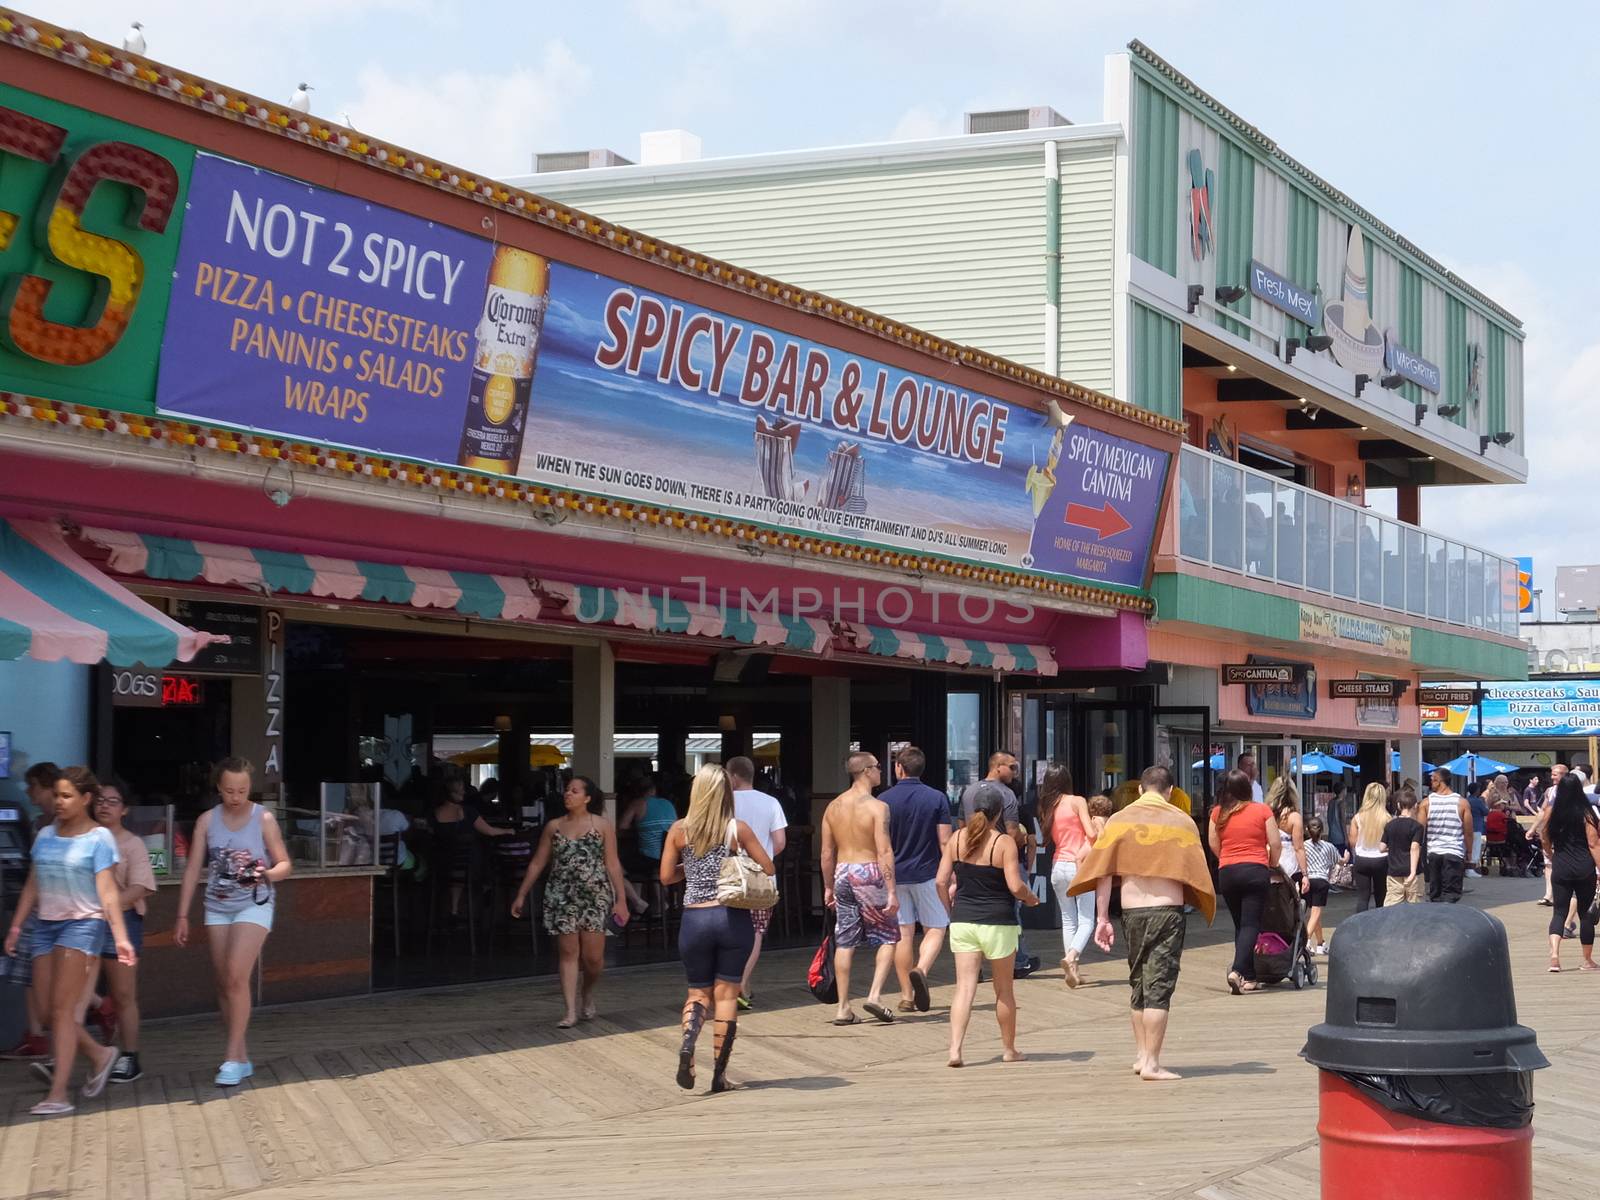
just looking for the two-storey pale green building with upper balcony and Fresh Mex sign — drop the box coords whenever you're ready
[523,43,1528,812]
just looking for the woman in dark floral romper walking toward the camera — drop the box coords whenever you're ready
[510,776,629,1029]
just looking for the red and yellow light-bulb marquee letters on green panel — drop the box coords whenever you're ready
[0,107,179,366]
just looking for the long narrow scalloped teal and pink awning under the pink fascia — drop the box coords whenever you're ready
[82,528,1056,675]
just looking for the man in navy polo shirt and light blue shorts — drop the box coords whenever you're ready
[878,746,950,1013]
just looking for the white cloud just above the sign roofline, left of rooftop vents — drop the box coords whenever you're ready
[347,42,590,176]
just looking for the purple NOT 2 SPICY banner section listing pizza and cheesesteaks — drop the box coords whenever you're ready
[155,154,494,461]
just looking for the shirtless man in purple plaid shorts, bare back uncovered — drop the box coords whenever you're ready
[822,750,899,1026]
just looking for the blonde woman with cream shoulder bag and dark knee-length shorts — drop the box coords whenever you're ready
[661,763,773,1091]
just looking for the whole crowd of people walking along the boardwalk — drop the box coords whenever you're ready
[5,746,1600,1115]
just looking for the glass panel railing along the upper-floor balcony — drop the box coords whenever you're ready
[1178,446,1518,637]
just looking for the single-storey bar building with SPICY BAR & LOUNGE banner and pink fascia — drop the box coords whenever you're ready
[0,18,1182,1013]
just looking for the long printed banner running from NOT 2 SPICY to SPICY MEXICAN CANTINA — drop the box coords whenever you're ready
[158,154,1171,587]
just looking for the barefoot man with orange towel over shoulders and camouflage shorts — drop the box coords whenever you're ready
[1070,766,1216,1082]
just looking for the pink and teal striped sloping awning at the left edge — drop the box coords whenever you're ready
[0,520,227,667]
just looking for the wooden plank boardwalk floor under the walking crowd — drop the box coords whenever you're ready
[0,878,1600,1200]
